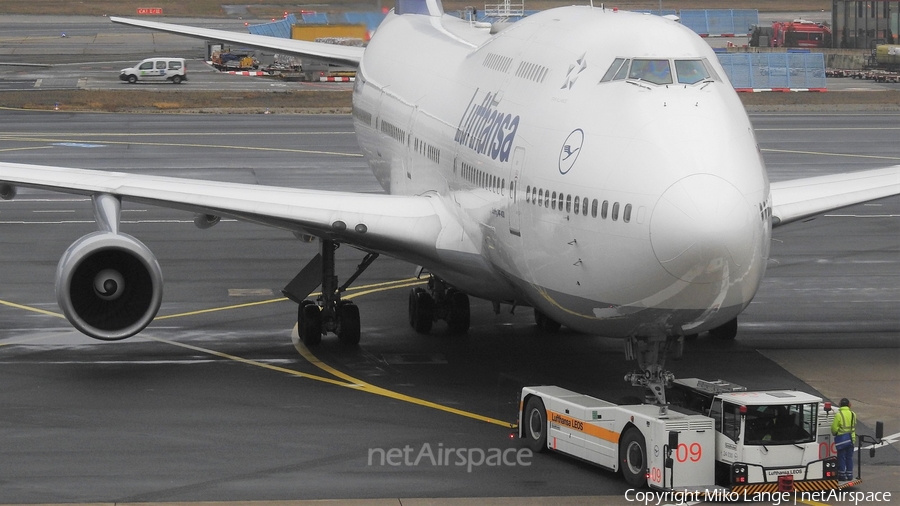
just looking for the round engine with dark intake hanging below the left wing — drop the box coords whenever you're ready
[56,232,163,341]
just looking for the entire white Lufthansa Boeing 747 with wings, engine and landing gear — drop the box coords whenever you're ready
[0,0,900,403]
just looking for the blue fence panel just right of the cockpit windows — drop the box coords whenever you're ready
[718,53,825,91]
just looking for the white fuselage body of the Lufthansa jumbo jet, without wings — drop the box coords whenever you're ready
[353,7,771,337]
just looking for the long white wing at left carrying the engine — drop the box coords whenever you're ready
[0,163,464,264]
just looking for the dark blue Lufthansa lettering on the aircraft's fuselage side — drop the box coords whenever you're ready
[453,90,519,162]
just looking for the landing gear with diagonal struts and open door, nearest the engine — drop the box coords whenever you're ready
[282,239,378,346]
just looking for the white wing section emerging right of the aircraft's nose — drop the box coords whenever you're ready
[771,165,900,227]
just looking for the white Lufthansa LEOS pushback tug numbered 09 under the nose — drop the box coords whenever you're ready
[519,378,872,495]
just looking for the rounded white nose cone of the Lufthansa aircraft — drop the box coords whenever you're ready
[650,174,756,283]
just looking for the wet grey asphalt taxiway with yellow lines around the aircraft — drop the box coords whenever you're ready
[0,111,900,504]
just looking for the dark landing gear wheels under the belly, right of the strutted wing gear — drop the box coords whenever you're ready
[409,275,469,334]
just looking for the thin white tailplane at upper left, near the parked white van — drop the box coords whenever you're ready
[109,17,365,67]
